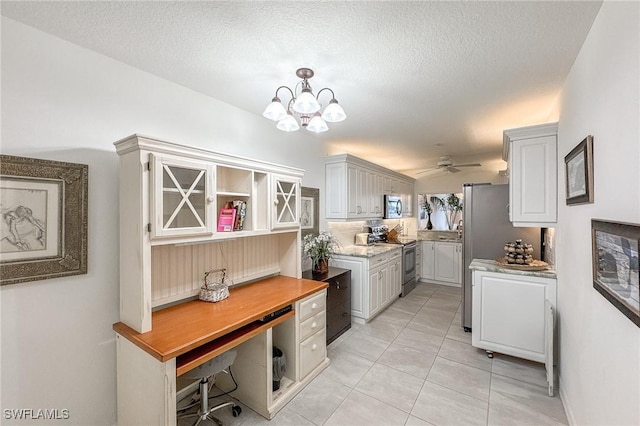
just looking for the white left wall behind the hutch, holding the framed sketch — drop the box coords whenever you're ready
[0,17,324,425]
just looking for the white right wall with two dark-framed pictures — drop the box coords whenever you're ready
[556,1,640,425]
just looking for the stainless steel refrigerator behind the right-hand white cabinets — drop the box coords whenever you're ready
[462,184,542,331]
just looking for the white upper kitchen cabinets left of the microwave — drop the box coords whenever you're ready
[325,154,414,220]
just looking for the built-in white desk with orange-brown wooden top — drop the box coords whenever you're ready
[113,276,329,425]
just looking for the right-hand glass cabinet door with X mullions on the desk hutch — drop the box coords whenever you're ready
[271,175,300,229]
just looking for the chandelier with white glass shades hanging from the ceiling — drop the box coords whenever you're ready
[262,68,347,133]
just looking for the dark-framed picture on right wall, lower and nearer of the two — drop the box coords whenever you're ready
[591,219,640,327]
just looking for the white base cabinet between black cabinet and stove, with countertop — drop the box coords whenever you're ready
[331,248,402,321]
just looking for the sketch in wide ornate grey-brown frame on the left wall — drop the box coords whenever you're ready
[0,155,88,285]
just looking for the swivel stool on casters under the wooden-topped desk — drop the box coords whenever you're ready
[178,349,242,426]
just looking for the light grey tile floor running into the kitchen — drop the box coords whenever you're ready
[180,283,568,426]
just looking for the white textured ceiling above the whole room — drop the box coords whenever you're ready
[1,1,601,175]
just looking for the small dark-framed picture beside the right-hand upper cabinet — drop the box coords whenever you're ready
[564,136,593,205]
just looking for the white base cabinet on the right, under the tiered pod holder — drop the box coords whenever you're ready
[471,270,556,394]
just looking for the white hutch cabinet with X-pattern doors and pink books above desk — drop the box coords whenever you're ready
[115,135,303,245]
